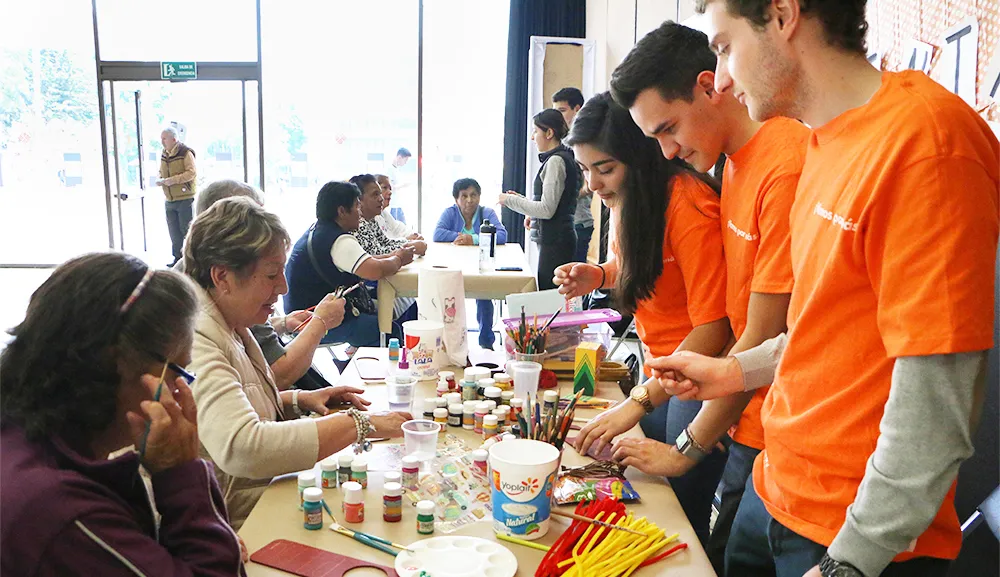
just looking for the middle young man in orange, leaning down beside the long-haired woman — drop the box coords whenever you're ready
[581,22,809,574]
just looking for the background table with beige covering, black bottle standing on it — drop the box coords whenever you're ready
[378,242,537,334]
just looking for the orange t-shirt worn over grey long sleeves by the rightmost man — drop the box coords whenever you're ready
[753,71,1000,561]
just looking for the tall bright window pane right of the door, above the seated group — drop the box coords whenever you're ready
[261,0,418,239]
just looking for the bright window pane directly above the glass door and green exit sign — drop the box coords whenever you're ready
[95,0,257,62]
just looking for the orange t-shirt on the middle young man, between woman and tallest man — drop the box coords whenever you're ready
[722,118,809,449]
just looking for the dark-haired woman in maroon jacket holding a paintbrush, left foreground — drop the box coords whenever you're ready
[0,253,245,576]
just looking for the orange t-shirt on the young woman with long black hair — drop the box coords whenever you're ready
[608,173,726,357]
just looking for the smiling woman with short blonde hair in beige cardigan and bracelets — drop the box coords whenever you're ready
[184,198,410,529]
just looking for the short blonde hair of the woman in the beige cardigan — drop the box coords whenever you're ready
[184,196,291,289]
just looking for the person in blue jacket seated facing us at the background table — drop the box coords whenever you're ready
[434,178,507,350]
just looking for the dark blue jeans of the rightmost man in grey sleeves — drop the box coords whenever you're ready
[726,479,950,577]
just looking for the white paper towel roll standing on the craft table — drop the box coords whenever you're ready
[417,266,469,367]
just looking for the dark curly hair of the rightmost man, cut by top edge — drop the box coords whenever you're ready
[695,0,868,56]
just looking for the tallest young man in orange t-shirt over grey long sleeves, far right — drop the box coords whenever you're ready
[650,0,1000,577]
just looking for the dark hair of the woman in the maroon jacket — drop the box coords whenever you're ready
[0,252,197,444]
